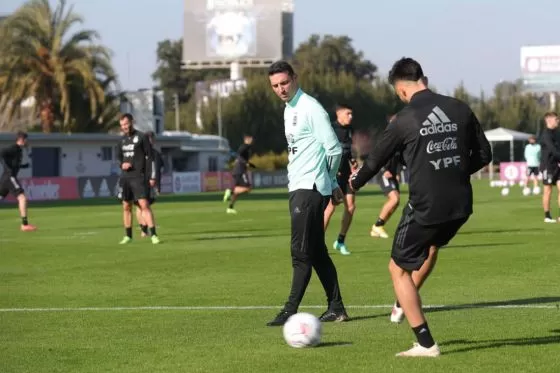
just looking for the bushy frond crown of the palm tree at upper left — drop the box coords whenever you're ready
[0,0,116,132]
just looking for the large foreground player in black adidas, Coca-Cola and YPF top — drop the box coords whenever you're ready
[350,58,492,357]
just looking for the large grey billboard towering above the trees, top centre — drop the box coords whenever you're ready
[183,0,293,68]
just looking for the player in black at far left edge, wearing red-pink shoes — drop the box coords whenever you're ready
[0,131,37,232]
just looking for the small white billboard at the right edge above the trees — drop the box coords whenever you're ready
[521,45,560,93]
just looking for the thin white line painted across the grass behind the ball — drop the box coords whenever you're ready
[0,304,560,312]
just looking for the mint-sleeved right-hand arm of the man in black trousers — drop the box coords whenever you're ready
[309,106,342,190]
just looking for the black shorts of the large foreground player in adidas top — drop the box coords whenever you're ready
[391,203,469,271]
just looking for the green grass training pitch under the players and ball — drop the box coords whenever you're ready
[0,182,560,373]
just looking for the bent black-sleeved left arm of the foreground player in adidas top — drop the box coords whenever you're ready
[350,120,403,191]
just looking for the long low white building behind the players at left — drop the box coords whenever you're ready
[0,132,230,178]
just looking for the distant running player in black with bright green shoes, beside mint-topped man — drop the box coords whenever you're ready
[224,135,255,214]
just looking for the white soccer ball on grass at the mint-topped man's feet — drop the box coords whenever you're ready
[283,312,322,348]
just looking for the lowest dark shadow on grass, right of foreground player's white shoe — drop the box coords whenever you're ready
[442,329,560,354]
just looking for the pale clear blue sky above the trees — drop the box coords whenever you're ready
[0,0,560,93]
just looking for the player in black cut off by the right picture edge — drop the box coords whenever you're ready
[541,112,560,223]
